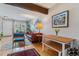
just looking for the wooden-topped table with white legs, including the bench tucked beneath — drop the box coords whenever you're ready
[42,35,74,55]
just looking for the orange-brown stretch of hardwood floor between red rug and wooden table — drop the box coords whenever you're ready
[33,43,58,56]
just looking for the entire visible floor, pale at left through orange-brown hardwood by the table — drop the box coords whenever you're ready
[0,37,57,56]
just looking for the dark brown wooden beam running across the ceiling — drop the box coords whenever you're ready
[6,3,48,14]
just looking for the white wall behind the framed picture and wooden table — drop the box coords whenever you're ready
[44,3,79,46]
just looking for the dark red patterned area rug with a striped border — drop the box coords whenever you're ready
[8,48,40,56]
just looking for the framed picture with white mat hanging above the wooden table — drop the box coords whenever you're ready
[52,10,69,28]
